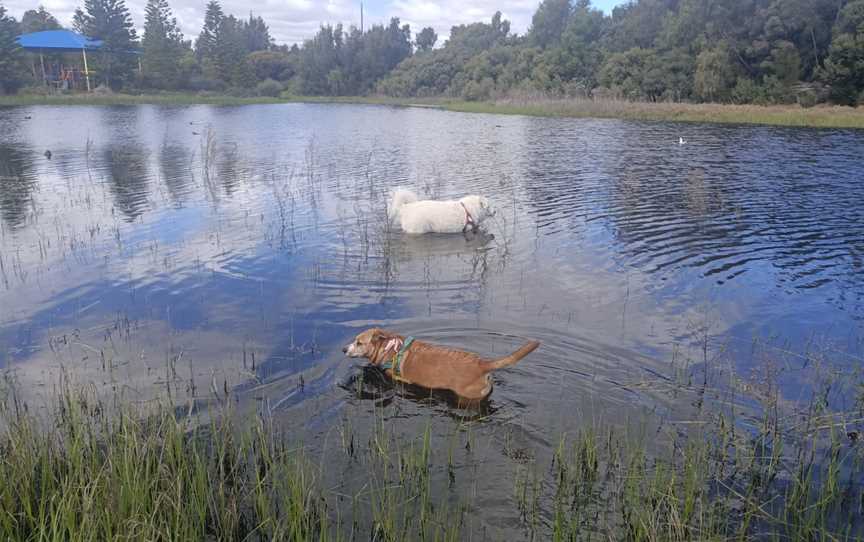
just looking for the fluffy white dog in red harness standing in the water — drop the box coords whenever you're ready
[390,188,495,234]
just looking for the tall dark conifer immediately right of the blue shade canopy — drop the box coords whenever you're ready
[73,0,138,89]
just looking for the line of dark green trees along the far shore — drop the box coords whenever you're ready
[0,0,864,105]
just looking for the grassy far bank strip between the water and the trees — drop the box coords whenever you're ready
[0,93,864,128]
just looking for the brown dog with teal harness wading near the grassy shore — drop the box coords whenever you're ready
[342,328,540,400]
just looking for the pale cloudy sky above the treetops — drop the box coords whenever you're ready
[6,0,625,44]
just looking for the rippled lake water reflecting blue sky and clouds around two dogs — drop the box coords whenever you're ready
[0,104,864,538]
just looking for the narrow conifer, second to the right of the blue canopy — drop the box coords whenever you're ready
[141,0,186,89]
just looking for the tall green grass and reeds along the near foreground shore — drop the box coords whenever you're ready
[0,374,864,541]
